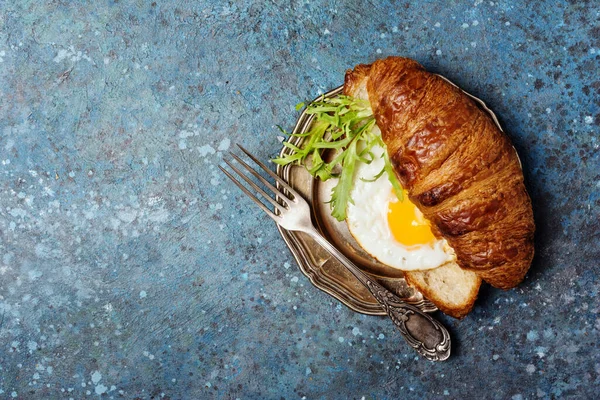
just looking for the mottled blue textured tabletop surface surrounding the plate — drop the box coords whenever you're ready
[0,0,600,400]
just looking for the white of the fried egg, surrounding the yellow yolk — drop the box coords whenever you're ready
[346,127,454,271]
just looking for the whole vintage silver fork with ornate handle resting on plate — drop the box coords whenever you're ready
[219,144,450,361]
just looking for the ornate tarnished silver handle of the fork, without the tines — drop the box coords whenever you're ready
[305,228,450,361]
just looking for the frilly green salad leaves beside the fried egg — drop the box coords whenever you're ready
[273,95,403,221]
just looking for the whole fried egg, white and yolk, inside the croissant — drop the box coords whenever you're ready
[346,128,455,271]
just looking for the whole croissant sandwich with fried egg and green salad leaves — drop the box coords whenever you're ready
[274,57,535,318]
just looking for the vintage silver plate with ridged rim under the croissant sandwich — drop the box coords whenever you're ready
[277,76,502,315]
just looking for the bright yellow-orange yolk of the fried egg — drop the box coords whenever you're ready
[387,191,436,246]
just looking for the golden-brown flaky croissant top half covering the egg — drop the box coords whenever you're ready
[344,57,535,289]
